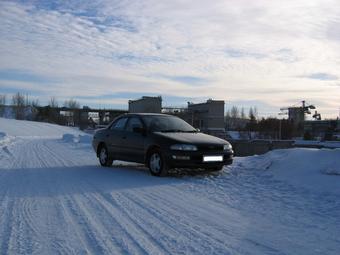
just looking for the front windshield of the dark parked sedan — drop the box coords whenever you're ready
[143,115,197,132]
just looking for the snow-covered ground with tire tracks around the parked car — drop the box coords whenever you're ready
[0,118,340,255]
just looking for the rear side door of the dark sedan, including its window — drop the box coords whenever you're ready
[106,117,128,159]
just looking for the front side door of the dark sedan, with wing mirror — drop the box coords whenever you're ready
[122,116,145,163]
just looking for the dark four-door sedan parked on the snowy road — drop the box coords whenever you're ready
[92,113,233,176]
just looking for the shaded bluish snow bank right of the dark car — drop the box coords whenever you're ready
[237,148,340,195]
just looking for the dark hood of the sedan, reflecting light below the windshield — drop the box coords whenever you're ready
[155,132,228,145]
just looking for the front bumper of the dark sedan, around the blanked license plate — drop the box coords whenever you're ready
[165,150,234,168]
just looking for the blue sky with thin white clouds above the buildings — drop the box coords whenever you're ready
[0,0,340,117]
